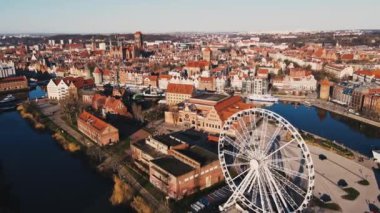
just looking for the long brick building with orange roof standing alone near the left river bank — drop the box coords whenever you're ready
[77,111,119,146]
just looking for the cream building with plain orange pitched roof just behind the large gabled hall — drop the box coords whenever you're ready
[165,83,195,105]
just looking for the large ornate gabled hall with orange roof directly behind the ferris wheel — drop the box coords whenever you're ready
[165,94,253,133]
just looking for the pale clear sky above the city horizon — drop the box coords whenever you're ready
[0,0,380,33]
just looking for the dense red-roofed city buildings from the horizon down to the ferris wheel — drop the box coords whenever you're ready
[0,32,380,200]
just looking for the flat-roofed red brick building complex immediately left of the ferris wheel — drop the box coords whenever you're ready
[131,135,224,200]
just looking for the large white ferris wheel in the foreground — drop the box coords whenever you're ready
[218,108,315,212]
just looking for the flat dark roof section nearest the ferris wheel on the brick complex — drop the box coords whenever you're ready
[176,146,218,166]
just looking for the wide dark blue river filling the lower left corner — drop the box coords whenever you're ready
[0,111,130,213]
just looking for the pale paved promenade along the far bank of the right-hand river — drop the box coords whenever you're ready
[275,95,380,128]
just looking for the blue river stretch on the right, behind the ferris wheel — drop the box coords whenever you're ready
[267,102,380,157]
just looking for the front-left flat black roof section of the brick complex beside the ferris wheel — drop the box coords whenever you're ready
[151,156,194,177]
